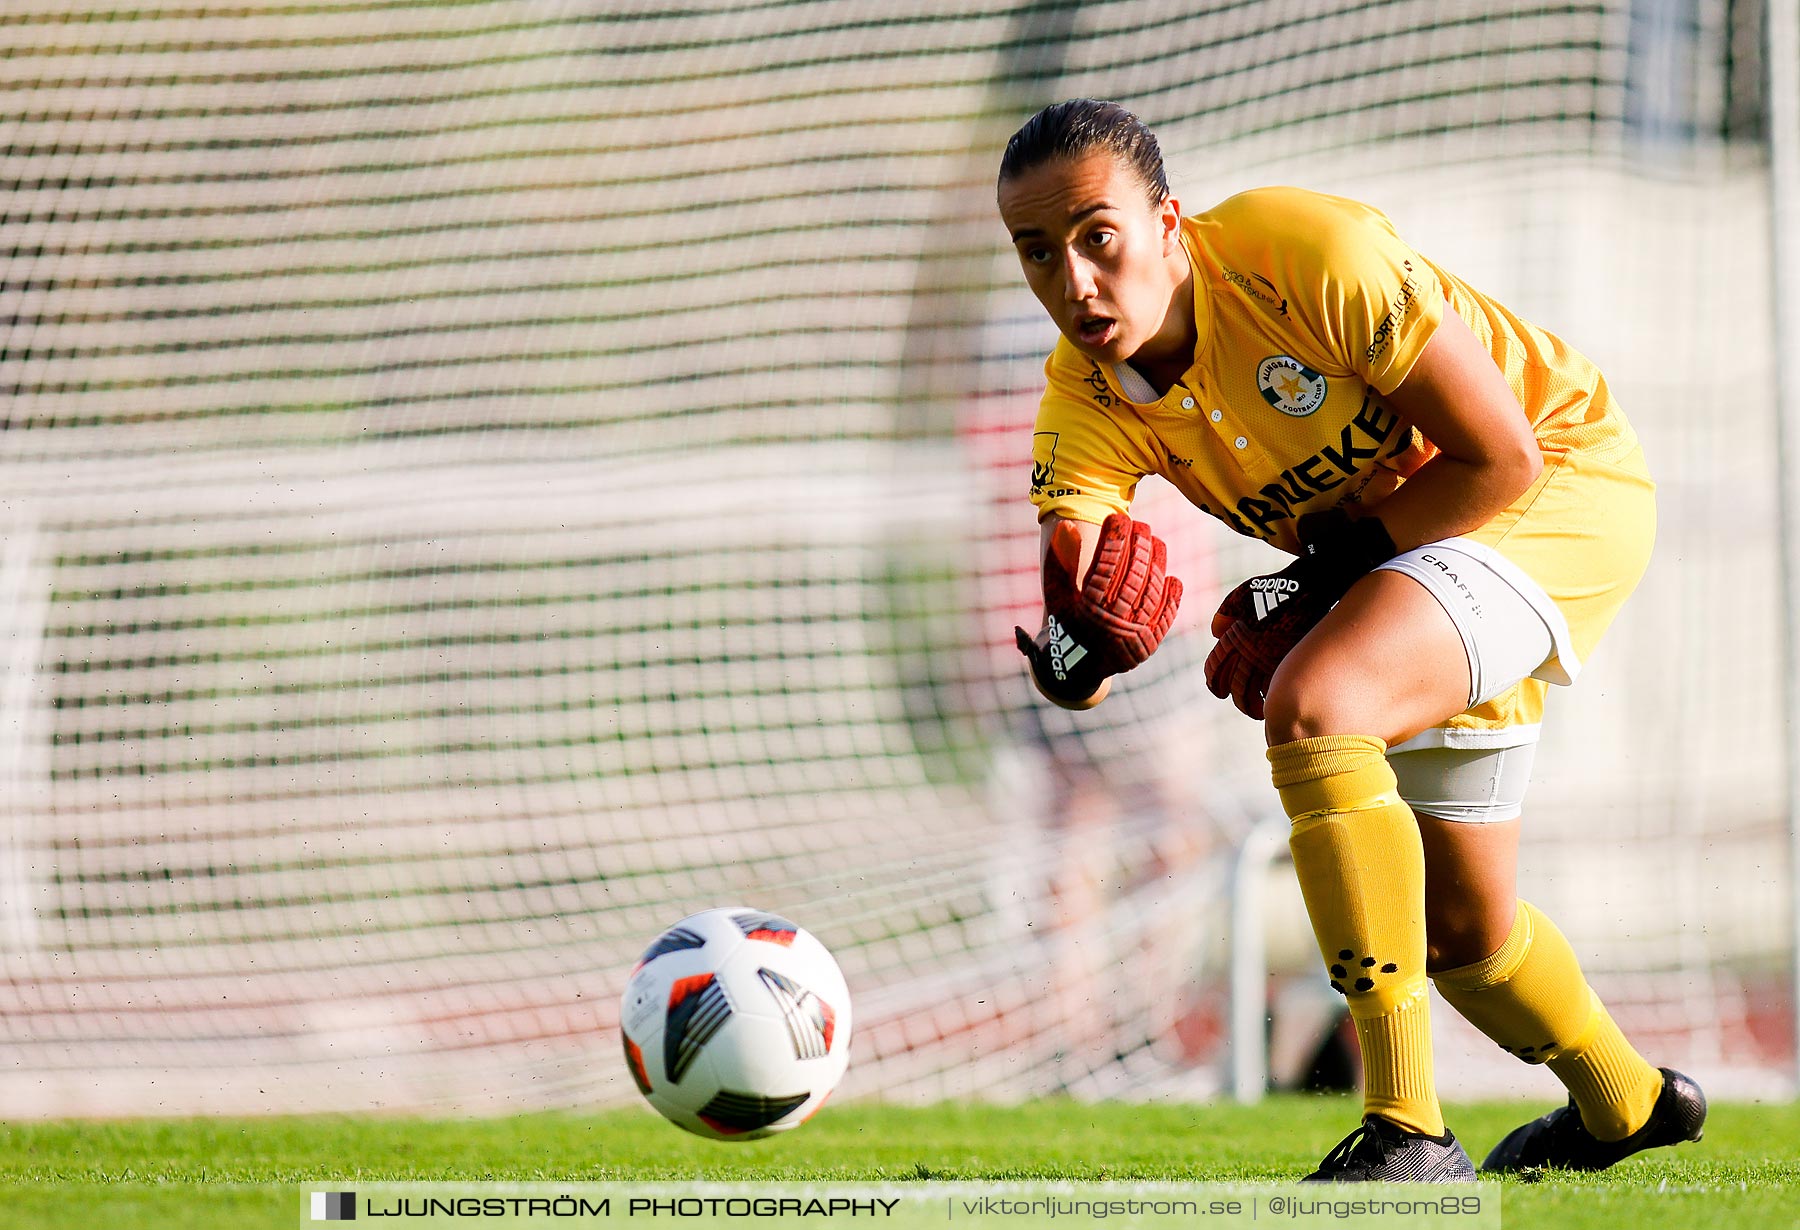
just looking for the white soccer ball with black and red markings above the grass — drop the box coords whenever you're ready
[619,906,850,1140]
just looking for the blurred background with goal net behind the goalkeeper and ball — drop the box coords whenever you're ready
[0,0,1795,1117]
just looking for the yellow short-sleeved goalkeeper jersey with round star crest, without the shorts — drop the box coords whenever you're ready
[1031,187,1636,551]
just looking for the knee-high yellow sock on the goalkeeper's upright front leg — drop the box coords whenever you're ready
[1269,735,1444,1136]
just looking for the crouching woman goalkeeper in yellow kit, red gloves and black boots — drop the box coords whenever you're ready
[999,99,1706,1181]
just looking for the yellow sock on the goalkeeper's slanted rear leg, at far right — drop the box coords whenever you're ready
[1433,900,1663,1140]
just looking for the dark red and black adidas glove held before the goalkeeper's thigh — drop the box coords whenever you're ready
[1206,508,1397,722]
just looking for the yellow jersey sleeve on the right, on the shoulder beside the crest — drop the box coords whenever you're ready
[1264,189,1444,394]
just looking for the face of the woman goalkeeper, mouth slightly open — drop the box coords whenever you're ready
[999,151,1186,364]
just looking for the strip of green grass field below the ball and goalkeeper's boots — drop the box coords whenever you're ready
[0,1097,1800,1230]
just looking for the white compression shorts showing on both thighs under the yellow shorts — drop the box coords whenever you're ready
[1381,540,1568,823]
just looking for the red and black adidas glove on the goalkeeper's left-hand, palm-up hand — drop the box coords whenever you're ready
[1013,513,1181,706]
